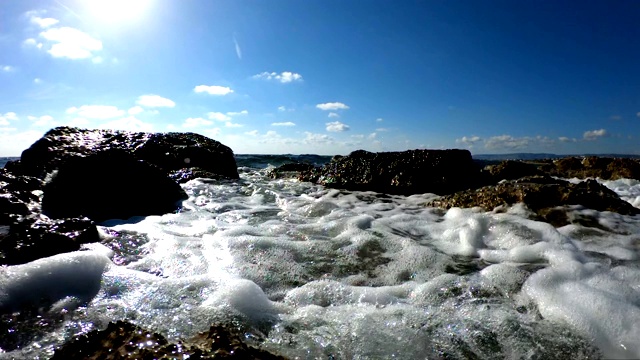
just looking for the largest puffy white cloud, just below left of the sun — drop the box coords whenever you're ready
[39,27,102,59]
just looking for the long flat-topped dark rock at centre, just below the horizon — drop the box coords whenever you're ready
[300,150,482,195]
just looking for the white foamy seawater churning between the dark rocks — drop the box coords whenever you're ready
[0,159,640,359]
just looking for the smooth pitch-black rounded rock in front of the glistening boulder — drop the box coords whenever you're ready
[42,150,187,222]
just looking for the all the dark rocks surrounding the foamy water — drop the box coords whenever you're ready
[0,127,640,359]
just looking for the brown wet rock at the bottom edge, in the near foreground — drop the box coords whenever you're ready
[51,321,284,360]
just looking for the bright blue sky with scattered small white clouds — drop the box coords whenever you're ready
[0,0,640,156]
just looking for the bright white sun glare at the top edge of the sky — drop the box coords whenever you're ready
[82,0,153,22]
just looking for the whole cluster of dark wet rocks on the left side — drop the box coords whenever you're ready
[0,127,239,265]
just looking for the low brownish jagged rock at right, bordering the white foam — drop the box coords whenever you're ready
[428,176,640,226]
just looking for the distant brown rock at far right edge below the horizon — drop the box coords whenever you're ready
[542,156,640,180]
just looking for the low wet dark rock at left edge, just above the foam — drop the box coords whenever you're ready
[0,215,100,265]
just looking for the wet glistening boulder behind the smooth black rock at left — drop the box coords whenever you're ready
[16,127,238,179]
